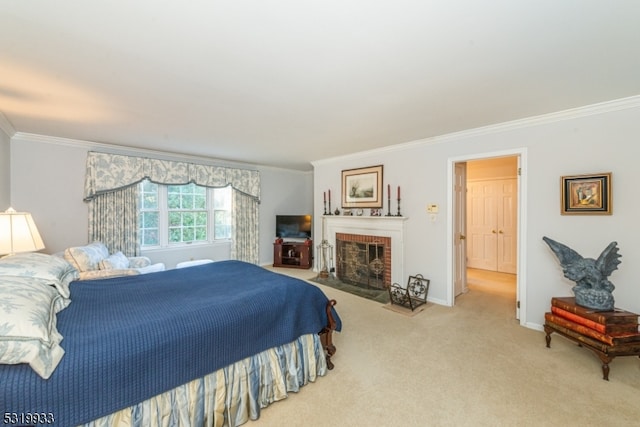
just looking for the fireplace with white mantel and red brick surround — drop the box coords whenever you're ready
[322,215,407,288]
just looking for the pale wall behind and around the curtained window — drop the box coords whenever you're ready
[8,134,313,268]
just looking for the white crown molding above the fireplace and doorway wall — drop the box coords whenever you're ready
[311,95,640,166]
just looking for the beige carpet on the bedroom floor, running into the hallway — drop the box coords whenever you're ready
[260,269,640,427]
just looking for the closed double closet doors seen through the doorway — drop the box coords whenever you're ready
[467,178,517,274]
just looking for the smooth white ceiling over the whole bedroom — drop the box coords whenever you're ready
[0,0,640,170]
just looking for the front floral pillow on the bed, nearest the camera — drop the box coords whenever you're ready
[0,276,70,379]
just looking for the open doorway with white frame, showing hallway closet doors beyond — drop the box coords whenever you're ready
[448,149,526,324]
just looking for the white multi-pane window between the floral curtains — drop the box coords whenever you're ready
[138,180,231,248]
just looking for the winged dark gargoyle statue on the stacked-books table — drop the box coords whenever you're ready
[542,236,621,311]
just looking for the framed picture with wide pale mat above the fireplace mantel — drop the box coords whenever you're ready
[342,165,383,208]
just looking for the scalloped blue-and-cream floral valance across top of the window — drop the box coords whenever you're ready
[84,152,260,201]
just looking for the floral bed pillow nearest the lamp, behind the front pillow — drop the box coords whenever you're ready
[0,252,78,298]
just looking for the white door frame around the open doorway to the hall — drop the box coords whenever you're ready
[447,147,527,326]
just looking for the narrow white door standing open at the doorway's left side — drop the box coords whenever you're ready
[453,163,467,297]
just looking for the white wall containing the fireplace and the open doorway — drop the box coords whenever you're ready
[313,97,640,328]
